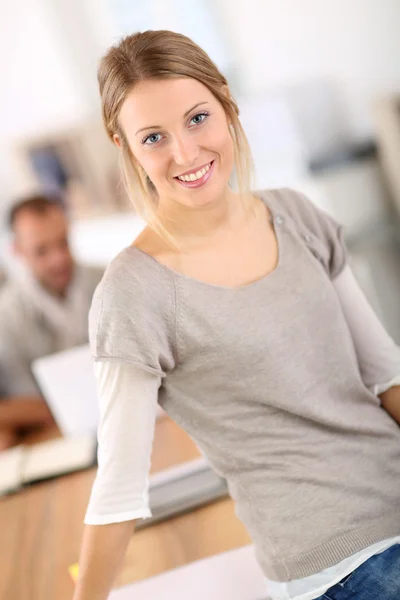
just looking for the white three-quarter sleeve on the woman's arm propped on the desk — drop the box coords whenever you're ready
[85,361,161,525]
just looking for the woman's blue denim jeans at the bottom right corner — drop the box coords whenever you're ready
[318,544,400,600]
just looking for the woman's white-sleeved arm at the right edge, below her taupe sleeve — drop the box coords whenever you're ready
[333,266,400,423]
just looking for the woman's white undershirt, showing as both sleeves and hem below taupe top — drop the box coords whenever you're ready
[85,266,400,600]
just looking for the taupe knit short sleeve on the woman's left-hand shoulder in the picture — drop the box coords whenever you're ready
[89,241,176,374]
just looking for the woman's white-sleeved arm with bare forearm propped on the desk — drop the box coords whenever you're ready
[73,362,161,600]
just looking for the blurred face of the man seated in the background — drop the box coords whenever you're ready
[14,207,74,294]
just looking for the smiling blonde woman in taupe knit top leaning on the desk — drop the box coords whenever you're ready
[74,31,400,600]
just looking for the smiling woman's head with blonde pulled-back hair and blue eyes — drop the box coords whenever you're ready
[99,31,252,246]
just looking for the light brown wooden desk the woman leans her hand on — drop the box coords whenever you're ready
[0,417,250,600]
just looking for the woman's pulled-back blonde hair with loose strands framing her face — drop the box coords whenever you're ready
[98,30,253,247]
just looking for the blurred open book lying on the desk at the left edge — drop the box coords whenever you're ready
[0,435,97,495]
